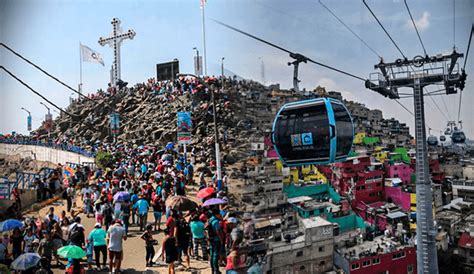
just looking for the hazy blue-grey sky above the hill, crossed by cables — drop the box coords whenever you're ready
[0,0,474,138]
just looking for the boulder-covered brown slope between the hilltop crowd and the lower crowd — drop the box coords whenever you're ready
[36,80,270,166]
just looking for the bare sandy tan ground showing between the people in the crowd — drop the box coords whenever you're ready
[29,185,225,274]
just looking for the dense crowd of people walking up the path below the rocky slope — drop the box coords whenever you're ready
[0,143,253,273]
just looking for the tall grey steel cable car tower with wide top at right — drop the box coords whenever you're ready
[365,50,467,274]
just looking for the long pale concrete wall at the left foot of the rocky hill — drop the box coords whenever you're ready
[0,144,95,164]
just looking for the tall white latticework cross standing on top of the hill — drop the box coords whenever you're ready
[99,18,136,87]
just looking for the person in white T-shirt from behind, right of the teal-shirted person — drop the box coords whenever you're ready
[107,219,127,273]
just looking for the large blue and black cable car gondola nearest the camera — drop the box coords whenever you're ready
[272,98,354,166]
